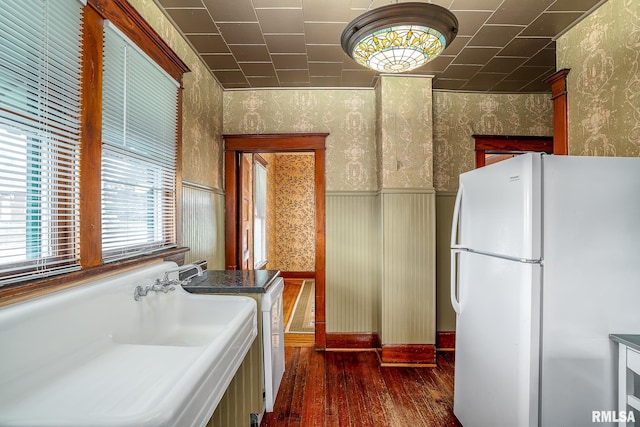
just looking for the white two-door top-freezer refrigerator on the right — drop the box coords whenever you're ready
[451,154,640,427]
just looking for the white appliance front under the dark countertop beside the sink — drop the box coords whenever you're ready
[260,277,284,412]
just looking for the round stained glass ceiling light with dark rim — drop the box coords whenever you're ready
[341,3,458,73]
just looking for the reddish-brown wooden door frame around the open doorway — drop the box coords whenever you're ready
[224,133,328,350]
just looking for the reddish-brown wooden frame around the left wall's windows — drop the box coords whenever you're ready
[0,0,190,306]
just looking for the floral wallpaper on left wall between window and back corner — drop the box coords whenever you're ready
[129,0,224,189]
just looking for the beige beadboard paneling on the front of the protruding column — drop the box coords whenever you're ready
[380,189,436,348]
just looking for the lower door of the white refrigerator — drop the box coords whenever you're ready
[453,252,541,427]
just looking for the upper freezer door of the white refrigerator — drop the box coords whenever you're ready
[452,153,542,261]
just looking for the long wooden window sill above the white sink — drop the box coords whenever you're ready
[0,247,189,307]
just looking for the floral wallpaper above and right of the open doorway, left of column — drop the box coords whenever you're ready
[223,89,377,191]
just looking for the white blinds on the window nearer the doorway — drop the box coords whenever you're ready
[102,25,178,262]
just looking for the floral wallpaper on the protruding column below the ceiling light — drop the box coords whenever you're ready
[377,76,433,188]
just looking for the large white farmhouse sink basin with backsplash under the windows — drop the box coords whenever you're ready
[0,263,257,427]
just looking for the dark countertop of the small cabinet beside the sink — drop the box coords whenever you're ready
[182,270,280,294]
